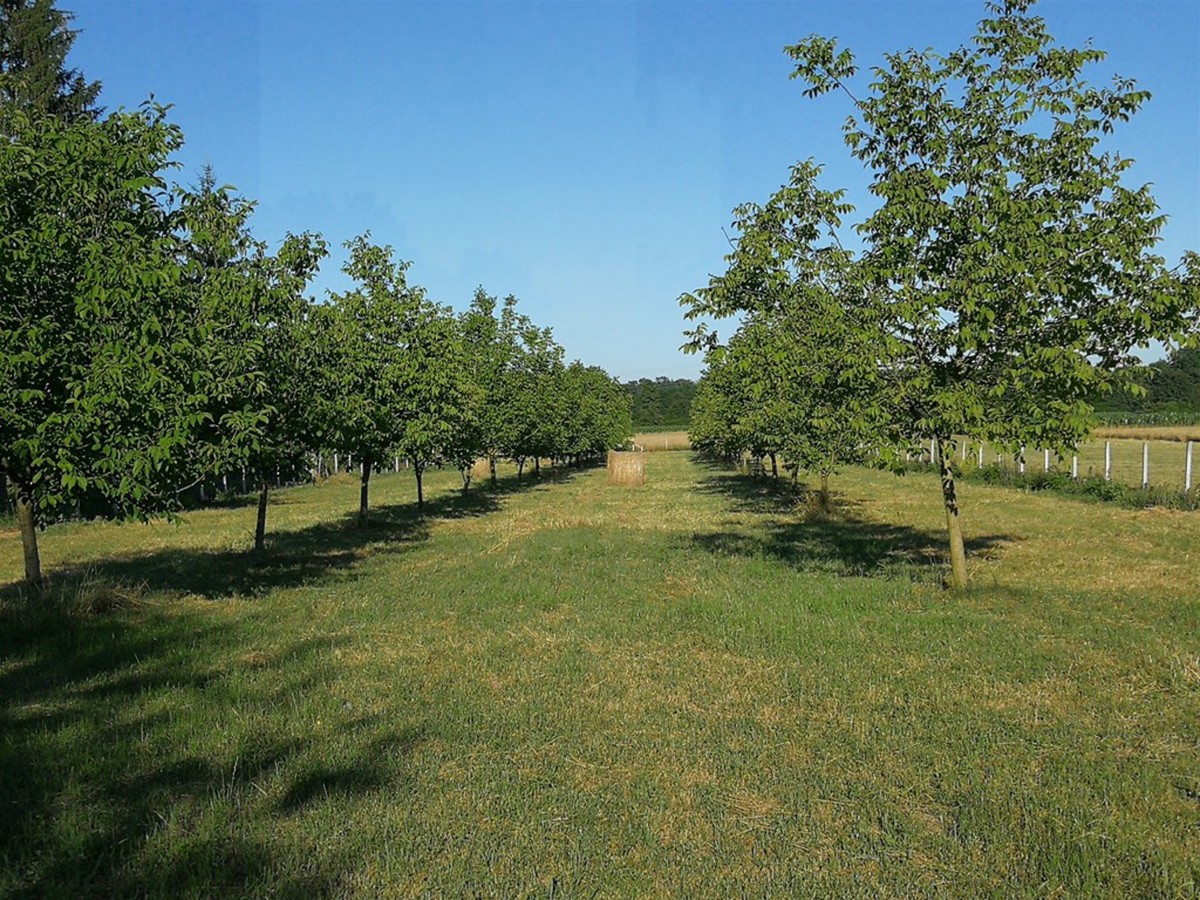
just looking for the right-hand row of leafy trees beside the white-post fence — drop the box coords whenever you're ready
[680,0,1200,587]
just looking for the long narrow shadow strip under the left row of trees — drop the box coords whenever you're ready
[0,468,590,604]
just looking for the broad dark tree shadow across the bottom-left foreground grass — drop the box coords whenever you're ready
[0,607,424,898]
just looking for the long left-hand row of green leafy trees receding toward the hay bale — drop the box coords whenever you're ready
[0,0,631,582]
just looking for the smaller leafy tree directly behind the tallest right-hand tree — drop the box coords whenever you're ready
[682,162,890,505]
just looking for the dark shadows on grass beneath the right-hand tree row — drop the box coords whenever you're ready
[691,464,1015,580]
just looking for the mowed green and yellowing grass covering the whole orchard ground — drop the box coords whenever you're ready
[0,452,1200,896]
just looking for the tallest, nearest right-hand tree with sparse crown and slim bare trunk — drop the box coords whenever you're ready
[696,0,1198,588]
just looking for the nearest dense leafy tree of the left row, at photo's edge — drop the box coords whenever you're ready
[0,106,208,583]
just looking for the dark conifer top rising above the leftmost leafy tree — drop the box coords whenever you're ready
[0,0,101,134]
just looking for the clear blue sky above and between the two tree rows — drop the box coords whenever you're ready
[70,0,1200,379]
